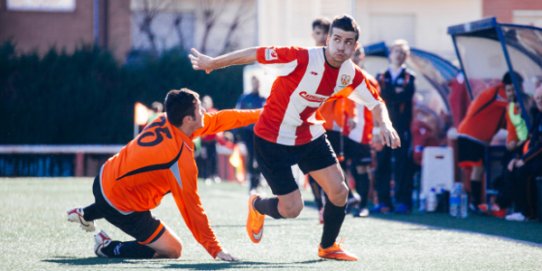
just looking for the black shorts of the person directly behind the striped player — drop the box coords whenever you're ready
[326,131,372,167]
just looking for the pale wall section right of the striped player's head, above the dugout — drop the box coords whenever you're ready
[355,0,482,58]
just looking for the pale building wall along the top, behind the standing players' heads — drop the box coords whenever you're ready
[258,0,482,58]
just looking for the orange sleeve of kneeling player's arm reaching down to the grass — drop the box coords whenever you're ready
[171,175,222,258]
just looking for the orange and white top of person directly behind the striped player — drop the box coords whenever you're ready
[318,69,380,144]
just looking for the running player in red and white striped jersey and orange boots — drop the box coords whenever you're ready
[189,15,401,261]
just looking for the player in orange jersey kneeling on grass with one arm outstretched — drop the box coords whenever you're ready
[68,89,261,261]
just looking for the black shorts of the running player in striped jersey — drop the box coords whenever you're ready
[254,134,337,195]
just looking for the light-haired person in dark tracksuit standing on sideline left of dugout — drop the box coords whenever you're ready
[373,40,416,213]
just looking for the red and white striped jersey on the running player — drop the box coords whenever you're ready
[254,47,381,146]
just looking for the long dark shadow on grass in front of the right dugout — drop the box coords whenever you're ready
[371,213,542,247]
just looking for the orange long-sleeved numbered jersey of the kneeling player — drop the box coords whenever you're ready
[100,110,261,257]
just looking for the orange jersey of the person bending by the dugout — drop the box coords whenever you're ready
[457,84,515,143]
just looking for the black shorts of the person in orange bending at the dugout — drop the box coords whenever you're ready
[457,136,486,167]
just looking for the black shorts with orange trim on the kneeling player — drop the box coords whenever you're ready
[92,176,166,245]
